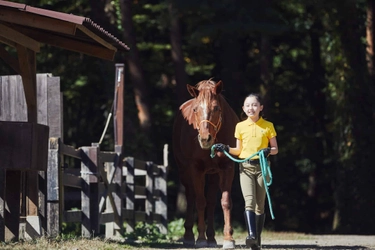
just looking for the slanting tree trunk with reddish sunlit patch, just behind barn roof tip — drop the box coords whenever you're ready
[120,0,152,134]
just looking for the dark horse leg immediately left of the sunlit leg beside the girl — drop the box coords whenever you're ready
[206,174,219,247]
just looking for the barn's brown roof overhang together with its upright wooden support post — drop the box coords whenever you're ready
[0,0,129,123]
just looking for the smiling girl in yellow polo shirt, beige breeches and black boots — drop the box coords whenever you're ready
[215,94,278,249]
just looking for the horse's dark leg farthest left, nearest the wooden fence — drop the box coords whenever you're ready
[184,183,195,246]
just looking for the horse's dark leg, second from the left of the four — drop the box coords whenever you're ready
[194,172,207,247]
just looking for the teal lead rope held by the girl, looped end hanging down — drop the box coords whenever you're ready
[210,145,275,220]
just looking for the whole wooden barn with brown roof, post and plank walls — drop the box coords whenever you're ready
[0,0,129,241]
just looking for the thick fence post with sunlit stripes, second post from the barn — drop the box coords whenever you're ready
[81,146,99,238]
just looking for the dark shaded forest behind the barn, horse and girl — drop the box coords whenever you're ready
[0,0,375,234]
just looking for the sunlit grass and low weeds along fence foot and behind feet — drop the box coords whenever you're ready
[0,219,310,250]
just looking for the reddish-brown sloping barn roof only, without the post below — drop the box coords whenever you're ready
[0,0,129,60]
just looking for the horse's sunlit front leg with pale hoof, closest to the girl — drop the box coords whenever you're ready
[220,167,235,249]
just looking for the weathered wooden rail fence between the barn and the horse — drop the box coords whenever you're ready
[47,138,168,238]
